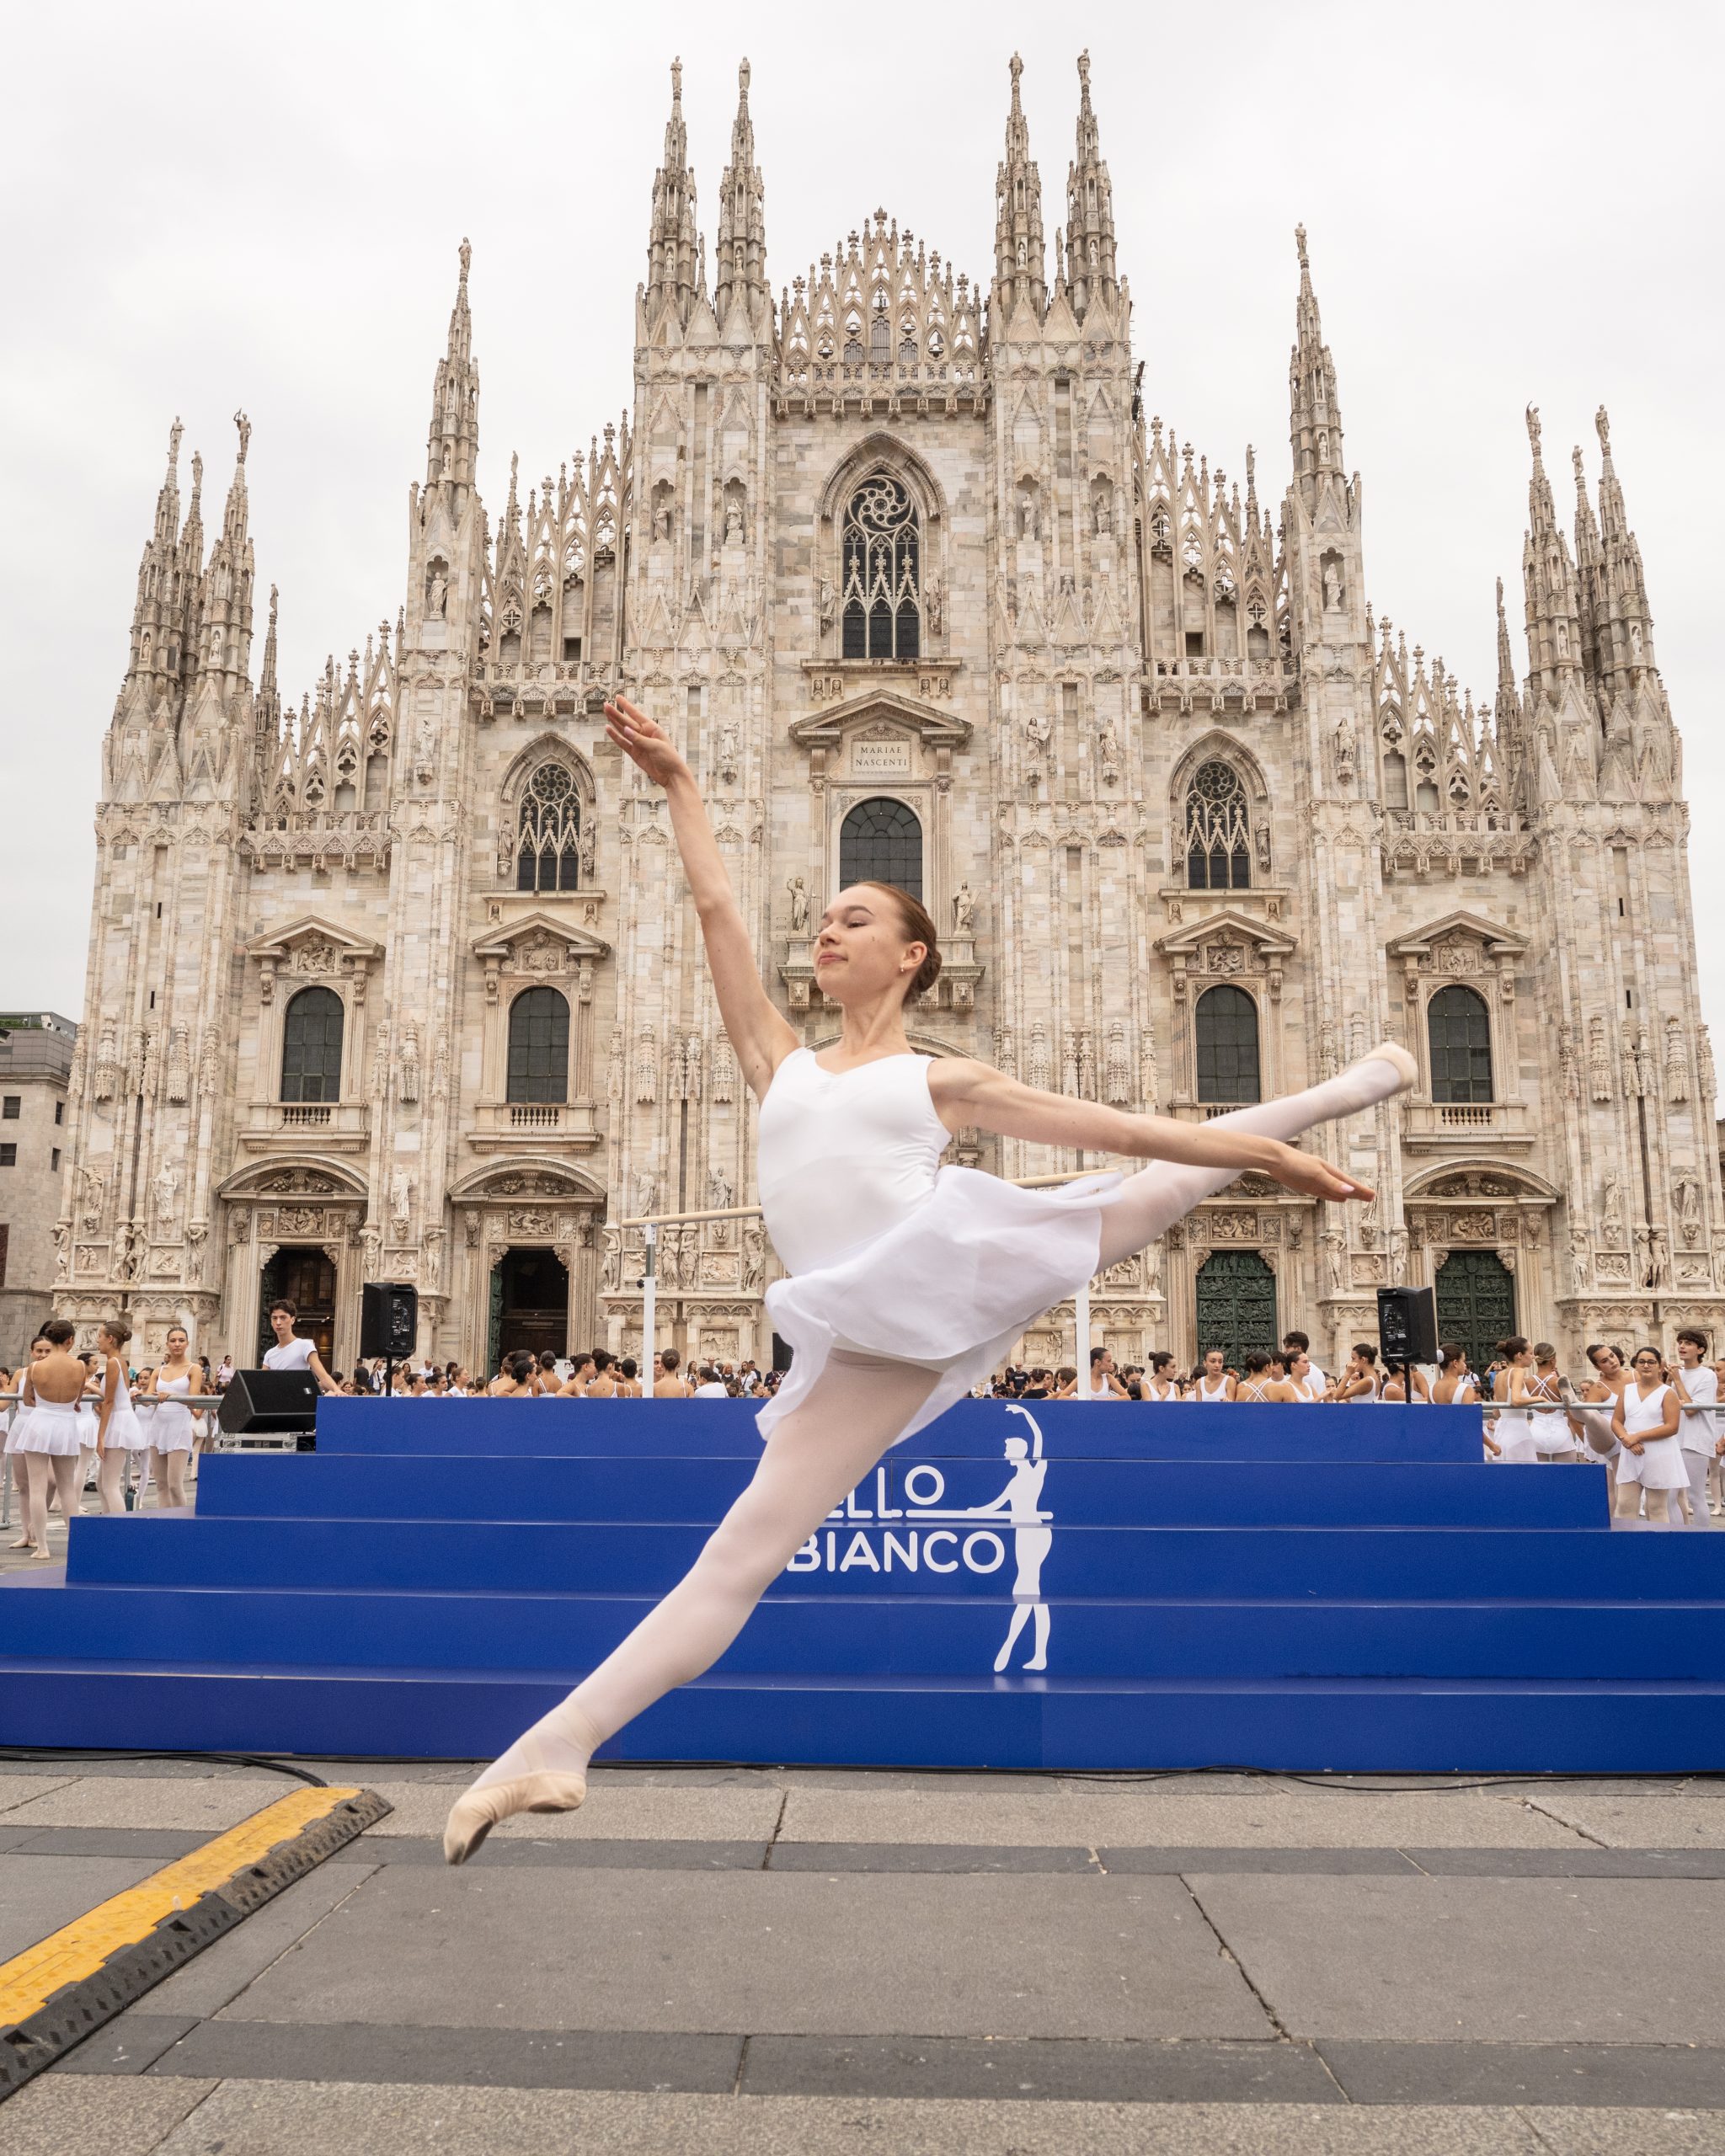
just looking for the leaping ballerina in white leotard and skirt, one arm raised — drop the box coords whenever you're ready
[444,698,1417,1863]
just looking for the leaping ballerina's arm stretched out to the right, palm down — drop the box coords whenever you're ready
[929,1056,1371,1198]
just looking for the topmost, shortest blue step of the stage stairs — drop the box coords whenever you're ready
[317,1397,1482,1466]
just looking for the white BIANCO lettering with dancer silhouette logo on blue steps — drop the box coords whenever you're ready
[785,1401,1055,1675]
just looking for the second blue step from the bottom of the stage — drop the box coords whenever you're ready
[7,1587,1725,1682]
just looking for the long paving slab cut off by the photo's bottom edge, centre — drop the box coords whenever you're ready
[148,2080,1552,2156]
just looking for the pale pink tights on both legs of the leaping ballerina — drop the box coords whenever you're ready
[474,1043,1402,1790]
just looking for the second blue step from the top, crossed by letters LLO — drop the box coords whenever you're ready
[199,1449,1609,1531]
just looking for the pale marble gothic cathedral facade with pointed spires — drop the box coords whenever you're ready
[56,61,1725,1367]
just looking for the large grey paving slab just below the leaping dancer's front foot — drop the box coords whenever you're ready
[209,1859,1270,2040]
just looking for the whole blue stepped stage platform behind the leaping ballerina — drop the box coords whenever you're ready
[0,1399,1725,1772]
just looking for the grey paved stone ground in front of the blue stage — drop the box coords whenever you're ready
[0,1757,1725,2156]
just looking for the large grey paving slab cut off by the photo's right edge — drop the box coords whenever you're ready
[1188,1874,1725,2044]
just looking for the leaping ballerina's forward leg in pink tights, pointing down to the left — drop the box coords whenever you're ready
[444,1350,936,1865]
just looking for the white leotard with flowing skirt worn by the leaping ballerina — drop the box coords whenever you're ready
[755,1048,1121,1444]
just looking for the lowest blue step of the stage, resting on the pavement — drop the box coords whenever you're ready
[0,1658,1725,1774]
